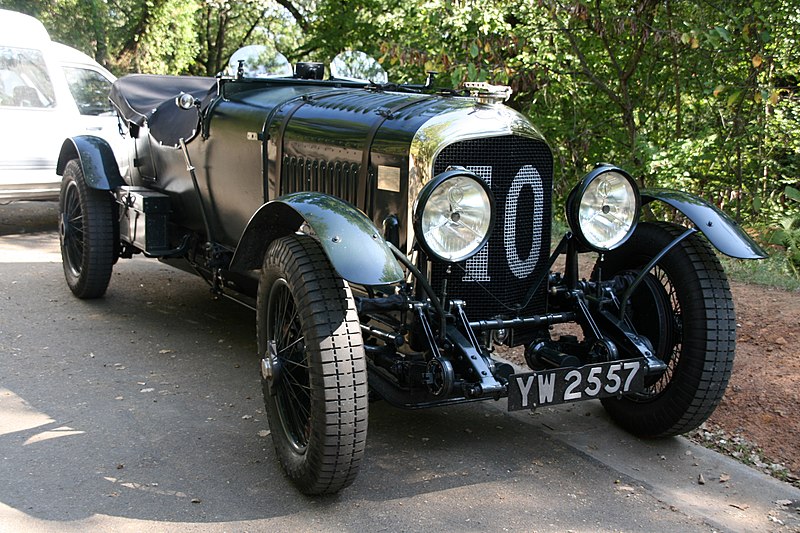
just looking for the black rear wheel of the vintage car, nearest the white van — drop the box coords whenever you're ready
[58,159,118,299]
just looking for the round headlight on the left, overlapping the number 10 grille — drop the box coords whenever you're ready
[414,168,494,263]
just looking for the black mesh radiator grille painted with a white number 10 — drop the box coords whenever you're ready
[431,135,553,320]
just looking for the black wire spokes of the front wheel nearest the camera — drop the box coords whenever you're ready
[267,279,311,453]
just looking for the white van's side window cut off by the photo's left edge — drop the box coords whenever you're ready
[0,46,55,107]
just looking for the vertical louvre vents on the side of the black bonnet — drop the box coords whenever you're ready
[281,156,360,204]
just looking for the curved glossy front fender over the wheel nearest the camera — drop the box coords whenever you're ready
[230,192,403,285]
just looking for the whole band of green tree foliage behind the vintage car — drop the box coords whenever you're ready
[0,0,800,233]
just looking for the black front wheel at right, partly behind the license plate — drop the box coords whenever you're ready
[595,223,736,437]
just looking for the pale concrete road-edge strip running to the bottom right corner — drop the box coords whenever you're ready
[504,402,800,533]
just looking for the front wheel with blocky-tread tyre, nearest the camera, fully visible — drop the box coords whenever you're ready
[256,235,368,494]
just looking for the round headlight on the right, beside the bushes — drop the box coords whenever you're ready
[566,165,641,252]
